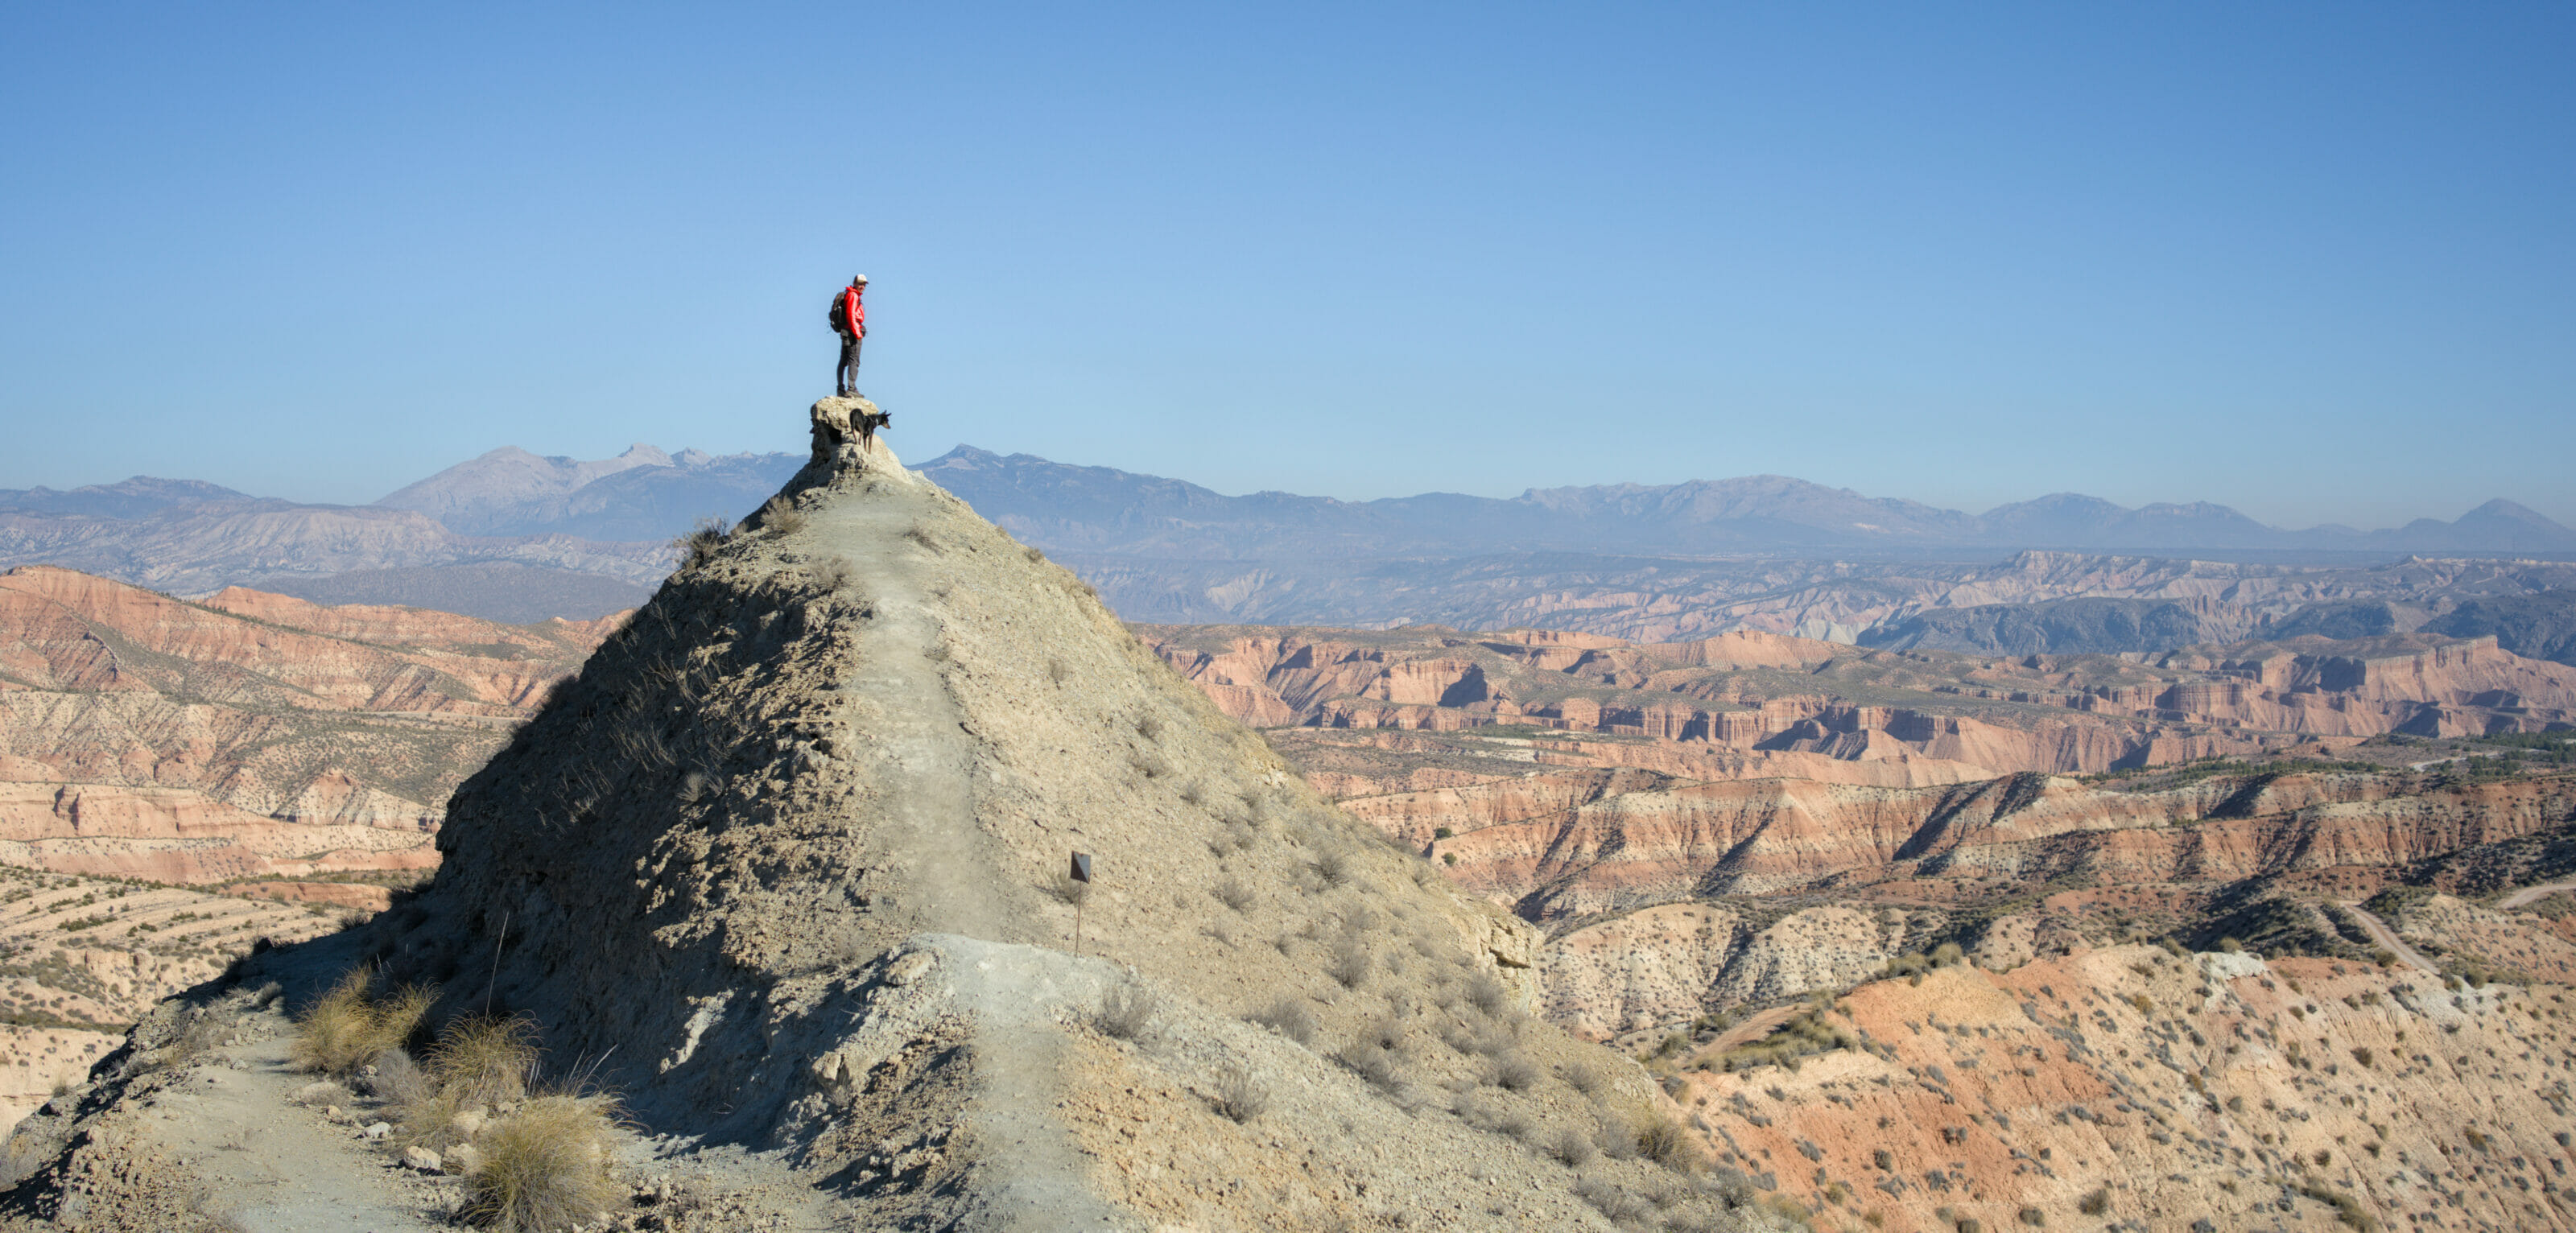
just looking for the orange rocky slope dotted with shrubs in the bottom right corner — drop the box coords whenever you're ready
[1657,947,2576,1231]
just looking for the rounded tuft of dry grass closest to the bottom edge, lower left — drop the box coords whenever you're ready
[464,1094,626,1233]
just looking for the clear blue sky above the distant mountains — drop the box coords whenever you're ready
[0,2,2576,525]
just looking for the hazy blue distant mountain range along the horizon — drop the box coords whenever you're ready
[0,445,2576,641]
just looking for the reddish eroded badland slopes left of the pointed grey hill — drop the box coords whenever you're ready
[0,567,616,883]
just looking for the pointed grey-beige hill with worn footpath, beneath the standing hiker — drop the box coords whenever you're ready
[10,399,1769,1231]
